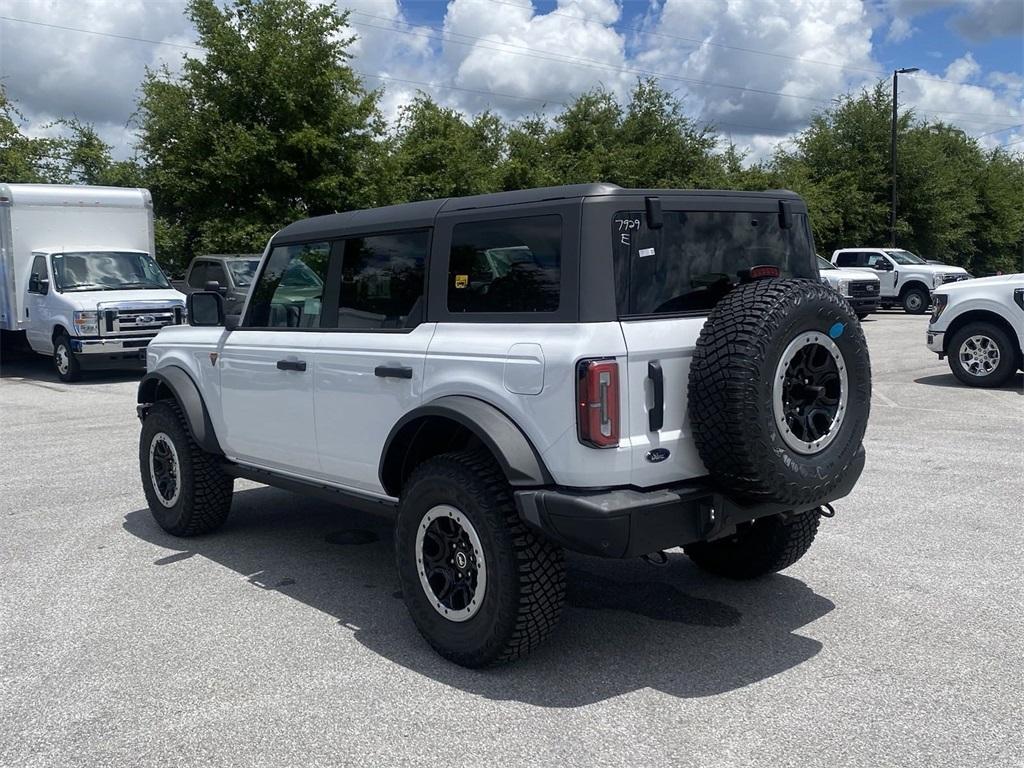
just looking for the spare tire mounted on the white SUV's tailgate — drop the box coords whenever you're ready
[689,280,871,505]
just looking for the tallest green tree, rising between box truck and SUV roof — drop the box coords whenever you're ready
[138,0,383,270]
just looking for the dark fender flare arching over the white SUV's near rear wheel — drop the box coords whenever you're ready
[378,395,554,496]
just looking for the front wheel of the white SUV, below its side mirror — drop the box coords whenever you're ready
[138,400,234,537]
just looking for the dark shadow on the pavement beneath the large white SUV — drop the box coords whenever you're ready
[124,487,835,708]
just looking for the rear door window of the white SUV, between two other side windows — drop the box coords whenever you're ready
[338,230,430,330]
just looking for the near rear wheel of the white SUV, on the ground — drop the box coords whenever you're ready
[395,452,565,668]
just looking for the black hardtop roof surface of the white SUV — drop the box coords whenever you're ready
[274,183,800,241]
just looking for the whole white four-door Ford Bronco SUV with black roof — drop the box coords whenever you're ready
[138,184,870,667]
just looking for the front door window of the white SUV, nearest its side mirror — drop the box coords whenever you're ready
[246,243,331,328]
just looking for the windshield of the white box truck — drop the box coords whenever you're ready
[51,251,171,292]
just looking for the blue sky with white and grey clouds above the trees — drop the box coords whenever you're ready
[0,0,1024,158]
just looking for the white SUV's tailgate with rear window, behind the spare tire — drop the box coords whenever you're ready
[609,198,818,487]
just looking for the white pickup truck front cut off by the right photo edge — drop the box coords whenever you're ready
[928,274,1024,387]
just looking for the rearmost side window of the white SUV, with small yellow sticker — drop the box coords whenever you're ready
[447,215,562,312]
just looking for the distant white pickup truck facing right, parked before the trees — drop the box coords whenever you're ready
[833,248,971,314]
